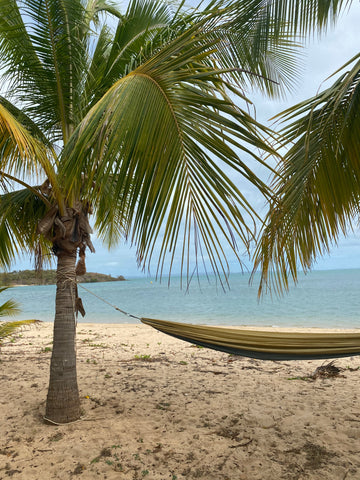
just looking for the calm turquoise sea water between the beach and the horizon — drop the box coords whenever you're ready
[4,270,360,328]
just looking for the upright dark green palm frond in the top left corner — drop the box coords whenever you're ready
[0,0,87,141]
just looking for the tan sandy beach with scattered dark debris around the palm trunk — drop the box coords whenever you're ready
[0,323,360,480]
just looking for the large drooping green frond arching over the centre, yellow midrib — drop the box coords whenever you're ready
[60,24,273,282]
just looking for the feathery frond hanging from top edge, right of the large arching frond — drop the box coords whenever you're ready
[190,1,302,96]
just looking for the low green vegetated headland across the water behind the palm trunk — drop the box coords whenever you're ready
[0,270,125,286]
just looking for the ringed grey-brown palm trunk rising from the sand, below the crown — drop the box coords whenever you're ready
[45,250,81,424]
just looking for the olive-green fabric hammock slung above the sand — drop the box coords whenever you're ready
[140,318,360,360]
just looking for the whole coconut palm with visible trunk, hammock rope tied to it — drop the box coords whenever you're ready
[0,0,347,423]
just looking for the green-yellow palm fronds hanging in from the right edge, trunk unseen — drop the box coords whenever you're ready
[255,54,360,293]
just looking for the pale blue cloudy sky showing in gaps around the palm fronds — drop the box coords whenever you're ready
[12,1,360,278]
